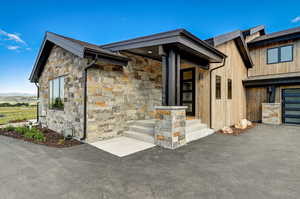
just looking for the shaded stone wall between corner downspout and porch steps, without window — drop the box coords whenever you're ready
[87,53,162,142]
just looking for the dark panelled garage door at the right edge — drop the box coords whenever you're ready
[282,88,300,124]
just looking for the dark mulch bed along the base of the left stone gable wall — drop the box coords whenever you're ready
[0,127,82,148]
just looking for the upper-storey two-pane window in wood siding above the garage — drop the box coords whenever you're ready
[267,45,293,64]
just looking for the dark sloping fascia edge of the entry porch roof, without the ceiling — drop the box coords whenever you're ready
[101,29,226,62]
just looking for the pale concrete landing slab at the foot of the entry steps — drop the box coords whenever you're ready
[90,136,155,157]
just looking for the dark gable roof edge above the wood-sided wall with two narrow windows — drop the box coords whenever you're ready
[205,30,253,68]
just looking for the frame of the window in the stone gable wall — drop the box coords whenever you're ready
[48,75,66,111]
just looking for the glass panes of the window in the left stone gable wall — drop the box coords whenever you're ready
[49,77,65,109]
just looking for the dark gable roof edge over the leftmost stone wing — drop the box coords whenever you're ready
[29,32,129,82]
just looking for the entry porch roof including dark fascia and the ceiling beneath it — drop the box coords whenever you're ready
[101,29,226,63]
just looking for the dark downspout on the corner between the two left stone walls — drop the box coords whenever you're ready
[80,54,98,141]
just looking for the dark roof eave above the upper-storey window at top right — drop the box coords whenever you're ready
[248,27,300,47]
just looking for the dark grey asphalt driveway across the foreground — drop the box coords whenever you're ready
[0,125,300,199]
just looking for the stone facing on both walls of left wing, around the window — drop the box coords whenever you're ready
[39,46,162,142]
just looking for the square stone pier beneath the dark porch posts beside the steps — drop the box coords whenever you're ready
[154,106,187,149]
